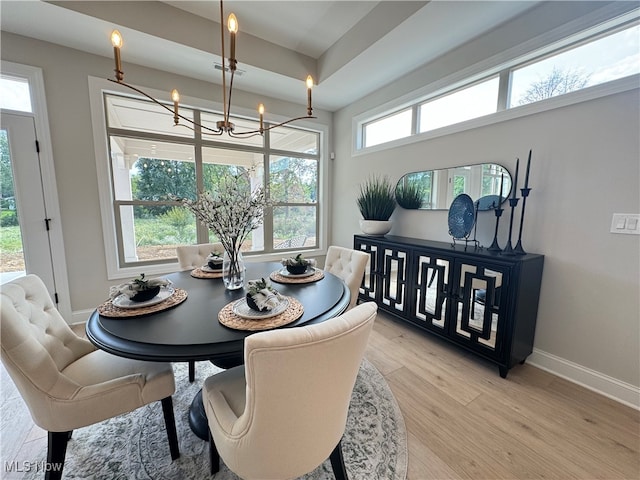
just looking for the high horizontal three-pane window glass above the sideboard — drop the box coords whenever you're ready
[355,17,640,151]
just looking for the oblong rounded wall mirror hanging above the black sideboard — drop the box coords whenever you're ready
[396,163,512,210]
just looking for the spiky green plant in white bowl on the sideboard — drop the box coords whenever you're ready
[357,175,396,235]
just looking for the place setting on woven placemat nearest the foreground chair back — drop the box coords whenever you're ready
[218,278,304,331]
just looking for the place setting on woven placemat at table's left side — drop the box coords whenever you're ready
[97,273,187,318]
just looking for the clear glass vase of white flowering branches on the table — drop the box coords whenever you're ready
[181,171,270,290]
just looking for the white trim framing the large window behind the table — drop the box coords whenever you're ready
[88,77,330,279]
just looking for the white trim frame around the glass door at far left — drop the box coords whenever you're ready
[0,60,73,323]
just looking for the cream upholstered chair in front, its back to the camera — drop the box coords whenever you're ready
[202,302,378,480]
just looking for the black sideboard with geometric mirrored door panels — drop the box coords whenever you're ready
[353,235,544,378]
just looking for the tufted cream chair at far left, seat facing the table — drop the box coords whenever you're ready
[0,275,180,480]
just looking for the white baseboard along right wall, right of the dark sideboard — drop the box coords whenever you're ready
[527,348,640,410]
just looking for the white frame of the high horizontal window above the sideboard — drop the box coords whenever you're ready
[351,8,640,156]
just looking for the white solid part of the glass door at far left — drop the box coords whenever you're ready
[0,114,57,302]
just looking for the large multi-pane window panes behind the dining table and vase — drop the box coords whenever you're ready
[103,93,320,267]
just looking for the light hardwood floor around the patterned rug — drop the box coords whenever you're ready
[0,313,640,480]
